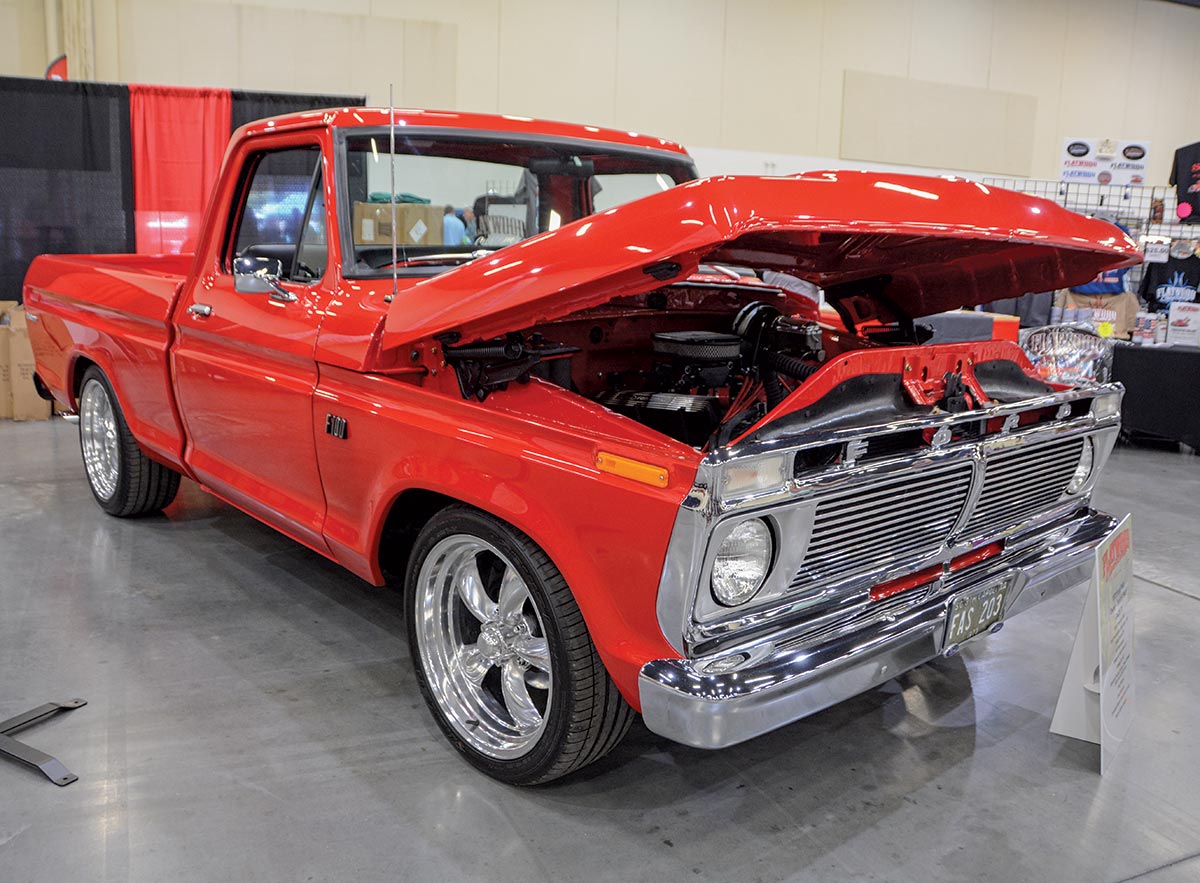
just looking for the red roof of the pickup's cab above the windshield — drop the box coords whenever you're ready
[234,107,688,156]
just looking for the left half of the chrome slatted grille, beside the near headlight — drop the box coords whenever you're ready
[788,461,972,591]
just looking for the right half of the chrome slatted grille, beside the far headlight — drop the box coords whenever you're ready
[962,438,1084,537]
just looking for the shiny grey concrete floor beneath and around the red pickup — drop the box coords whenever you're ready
[0,420,1200,883]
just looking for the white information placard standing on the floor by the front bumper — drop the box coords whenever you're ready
[1050,515,1134,775]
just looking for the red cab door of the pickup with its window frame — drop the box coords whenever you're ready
[170,130,335,553]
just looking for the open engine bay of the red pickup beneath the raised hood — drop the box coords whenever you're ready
[439,276,1065,451]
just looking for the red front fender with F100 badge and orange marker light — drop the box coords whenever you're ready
[313,368,700,702]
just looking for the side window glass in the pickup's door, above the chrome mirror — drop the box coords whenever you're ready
[233,146,325,282]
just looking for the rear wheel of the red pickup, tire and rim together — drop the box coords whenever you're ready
[79,366,179,518]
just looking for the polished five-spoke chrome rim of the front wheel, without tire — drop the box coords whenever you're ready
[415,534,553,759]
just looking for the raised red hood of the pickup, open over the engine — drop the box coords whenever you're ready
[379,172,1140,355]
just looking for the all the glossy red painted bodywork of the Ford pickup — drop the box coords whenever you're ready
[25,108,1134,707]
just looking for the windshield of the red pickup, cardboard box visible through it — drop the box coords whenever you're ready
[340,130,695,276]
